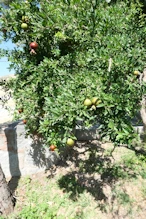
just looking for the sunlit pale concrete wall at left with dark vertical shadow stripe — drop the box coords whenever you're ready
[0,122,59,177]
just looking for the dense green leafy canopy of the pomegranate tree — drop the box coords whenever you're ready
[0,0,146,147]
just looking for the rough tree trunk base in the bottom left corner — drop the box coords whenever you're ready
[0,165,14,215]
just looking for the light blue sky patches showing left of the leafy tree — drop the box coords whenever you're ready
[0,41,15,77]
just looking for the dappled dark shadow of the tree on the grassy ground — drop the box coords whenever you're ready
[54,141,146,211]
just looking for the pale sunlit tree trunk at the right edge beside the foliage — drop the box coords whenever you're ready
[140,68,146,134]
